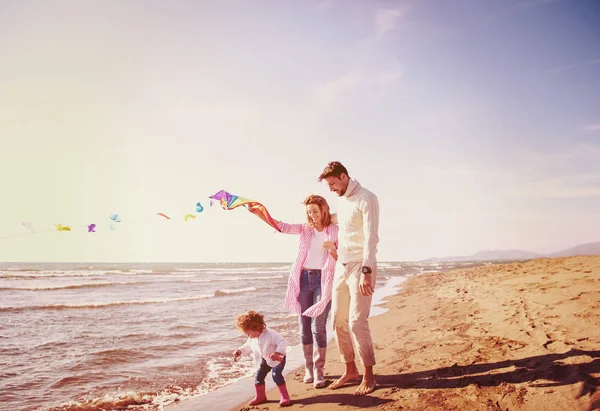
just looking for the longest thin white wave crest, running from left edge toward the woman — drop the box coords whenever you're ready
[0,287,256,312]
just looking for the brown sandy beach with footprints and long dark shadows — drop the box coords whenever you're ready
[221,256,600,411]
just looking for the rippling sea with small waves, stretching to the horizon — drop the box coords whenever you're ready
[0,262,488,411]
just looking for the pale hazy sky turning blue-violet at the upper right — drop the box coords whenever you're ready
[0,0,600,262]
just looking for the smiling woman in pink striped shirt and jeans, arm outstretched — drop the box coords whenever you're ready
[277,195,338,388]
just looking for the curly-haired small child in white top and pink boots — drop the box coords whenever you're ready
[233,311,291,407]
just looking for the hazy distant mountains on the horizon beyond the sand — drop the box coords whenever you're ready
[423,242,600,262]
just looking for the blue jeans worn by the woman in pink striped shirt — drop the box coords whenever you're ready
[298,270,331,348]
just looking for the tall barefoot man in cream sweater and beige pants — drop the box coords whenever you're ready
[319,161,379,395]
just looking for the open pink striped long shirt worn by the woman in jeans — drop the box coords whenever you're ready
[277,221,338,317]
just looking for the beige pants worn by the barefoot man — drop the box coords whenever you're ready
[331,262,376,367]
